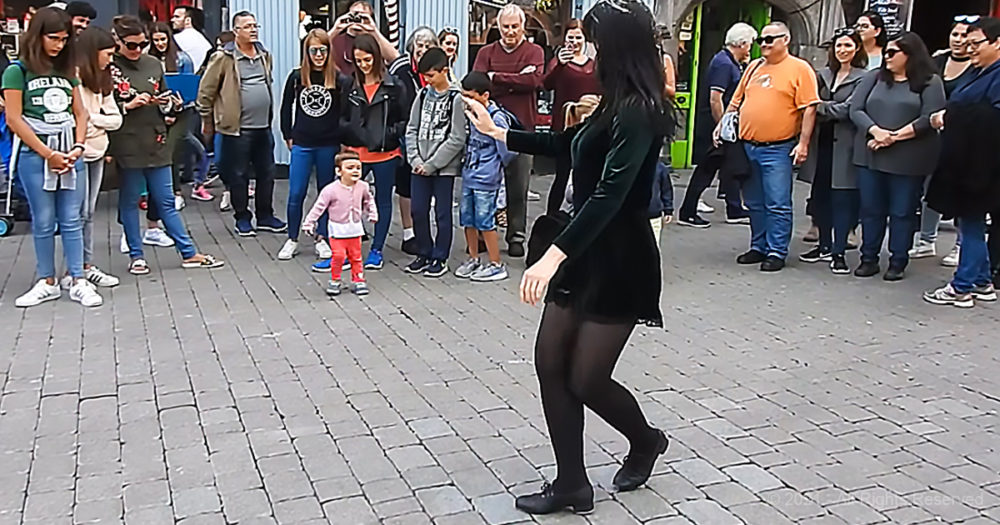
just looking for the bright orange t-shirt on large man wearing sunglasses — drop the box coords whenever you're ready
[730,55,819,142]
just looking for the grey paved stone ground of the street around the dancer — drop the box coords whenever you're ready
[0,173,1000,525]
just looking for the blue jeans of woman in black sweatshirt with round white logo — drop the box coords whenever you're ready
[288,144,340,241]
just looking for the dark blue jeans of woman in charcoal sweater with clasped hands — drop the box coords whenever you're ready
[858,167,924,268]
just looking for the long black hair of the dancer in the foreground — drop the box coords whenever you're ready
[584,0,673,133]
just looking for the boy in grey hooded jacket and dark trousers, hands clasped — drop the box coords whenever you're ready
[404,47,469,277]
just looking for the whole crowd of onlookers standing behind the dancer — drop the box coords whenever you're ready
[3,0,1000,307]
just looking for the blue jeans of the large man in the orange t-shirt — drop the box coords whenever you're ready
[743,141,795,259]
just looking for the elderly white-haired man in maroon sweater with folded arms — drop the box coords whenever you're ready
[472,4,545,257]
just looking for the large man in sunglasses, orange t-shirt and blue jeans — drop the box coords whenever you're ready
[713,22,819,272]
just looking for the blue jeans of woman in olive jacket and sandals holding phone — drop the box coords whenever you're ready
[118,166,198,259]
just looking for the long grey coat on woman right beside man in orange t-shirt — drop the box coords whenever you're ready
[799,67,865,190]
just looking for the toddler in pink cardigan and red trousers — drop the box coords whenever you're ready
[302,151,378,296]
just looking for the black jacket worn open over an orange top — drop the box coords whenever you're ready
[340,75,410,152]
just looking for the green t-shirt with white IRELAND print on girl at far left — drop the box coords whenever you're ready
[2,64,80,124]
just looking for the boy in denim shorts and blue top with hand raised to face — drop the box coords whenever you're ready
[455,71,514,282]
